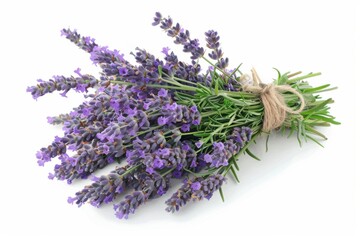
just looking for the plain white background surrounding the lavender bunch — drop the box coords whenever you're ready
[0,0,360,239]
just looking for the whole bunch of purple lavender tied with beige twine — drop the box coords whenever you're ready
[27,13,338,218]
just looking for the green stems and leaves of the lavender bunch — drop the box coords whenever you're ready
[116,64,340,185]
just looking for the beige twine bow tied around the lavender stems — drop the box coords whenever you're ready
[244,68,305,132]
